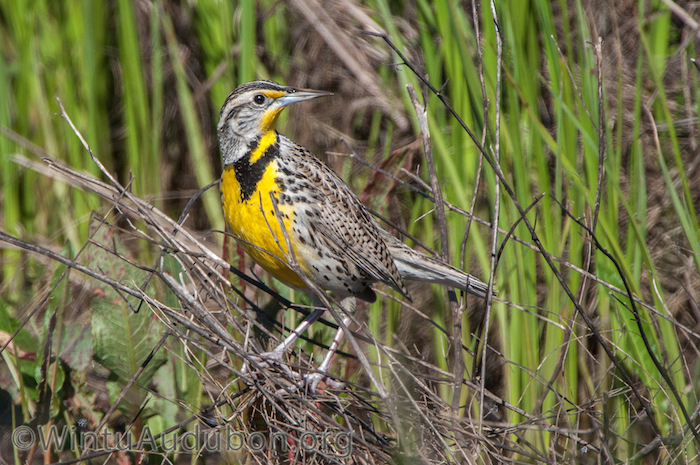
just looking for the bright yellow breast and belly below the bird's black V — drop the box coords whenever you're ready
[221,161,307,288]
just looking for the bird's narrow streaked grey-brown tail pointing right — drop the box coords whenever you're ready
[383,232,488,299]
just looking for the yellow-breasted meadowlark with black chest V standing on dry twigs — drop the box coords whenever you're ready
[217,81,487,388]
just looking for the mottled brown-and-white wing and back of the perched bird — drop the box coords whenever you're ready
[278,136,407,301]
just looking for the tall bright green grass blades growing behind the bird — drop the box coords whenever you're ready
[0,0,700,463]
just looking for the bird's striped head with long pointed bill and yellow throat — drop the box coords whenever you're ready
[217,81,332,165]
